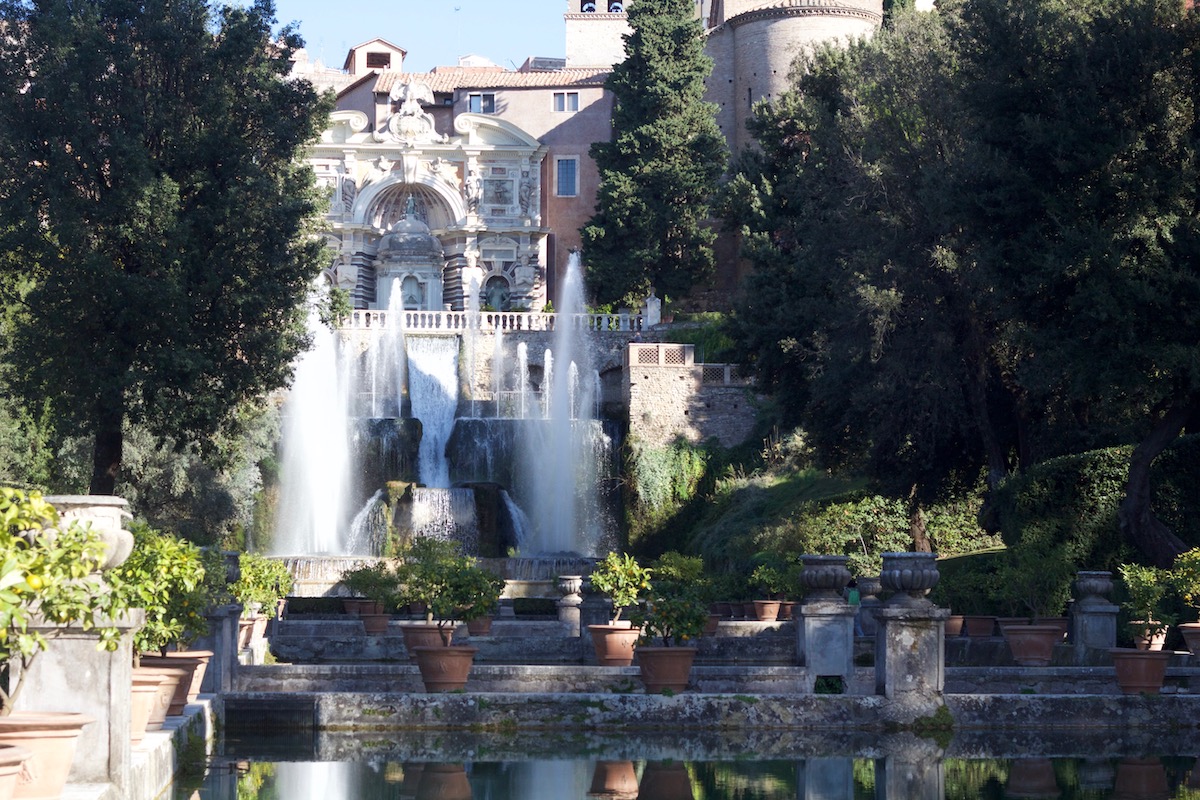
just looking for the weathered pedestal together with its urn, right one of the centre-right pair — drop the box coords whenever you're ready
[875,553,950,719]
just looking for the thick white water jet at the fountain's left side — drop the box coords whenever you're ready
[270,297,350,555]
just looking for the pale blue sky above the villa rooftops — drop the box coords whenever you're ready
[275,0,568,72]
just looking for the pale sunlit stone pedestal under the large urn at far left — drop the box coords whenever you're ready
[16,609,145,796]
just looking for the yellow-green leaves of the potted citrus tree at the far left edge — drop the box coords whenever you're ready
[0,487,128,715]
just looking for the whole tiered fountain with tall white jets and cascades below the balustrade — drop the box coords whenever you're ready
[272,254,616,571]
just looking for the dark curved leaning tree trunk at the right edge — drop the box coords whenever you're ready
[1117,395,1200,567]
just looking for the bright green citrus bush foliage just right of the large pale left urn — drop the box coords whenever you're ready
[108,522,207,654]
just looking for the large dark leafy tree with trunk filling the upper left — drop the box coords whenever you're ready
[0,0,329,494]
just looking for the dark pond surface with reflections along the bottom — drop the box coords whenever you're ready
[173,732,1200,800]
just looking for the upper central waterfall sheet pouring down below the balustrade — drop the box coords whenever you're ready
[407,336,458,488]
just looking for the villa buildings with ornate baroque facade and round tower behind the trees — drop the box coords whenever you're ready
[295,0,882,311]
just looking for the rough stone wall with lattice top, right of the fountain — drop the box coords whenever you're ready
[625,343,755,447]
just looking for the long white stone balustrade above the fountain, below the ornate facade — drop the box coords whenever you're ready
[342,309,643,332]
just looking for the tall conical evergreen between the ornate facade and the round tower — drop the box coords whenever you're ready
[582,0,726,302]
